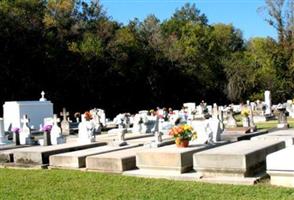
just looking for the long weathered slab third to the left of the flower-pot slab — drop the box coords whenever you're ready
[13,142,106,165]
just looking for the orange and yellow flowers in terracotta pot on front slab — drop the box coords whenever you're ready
[169,124,197,147]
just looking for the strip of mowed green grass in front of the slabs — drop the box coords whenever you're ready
[0,169,294,200]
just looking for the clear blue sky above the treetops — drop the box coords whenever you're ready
[100,0,276,40]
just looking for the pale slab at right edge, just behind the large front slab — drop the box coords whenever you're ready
[251,129,294,147]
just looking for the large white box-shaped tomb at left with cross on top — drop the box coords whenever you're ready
[3,92,53,131]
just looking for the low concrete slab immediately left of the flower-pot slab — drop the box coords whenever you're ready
[86,147,146,173]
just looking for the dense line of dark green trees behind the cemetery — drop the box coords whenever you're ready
[0,0,294,115]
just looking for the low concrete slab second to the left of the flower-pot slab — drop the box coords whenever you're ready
[49,145,139,168]
